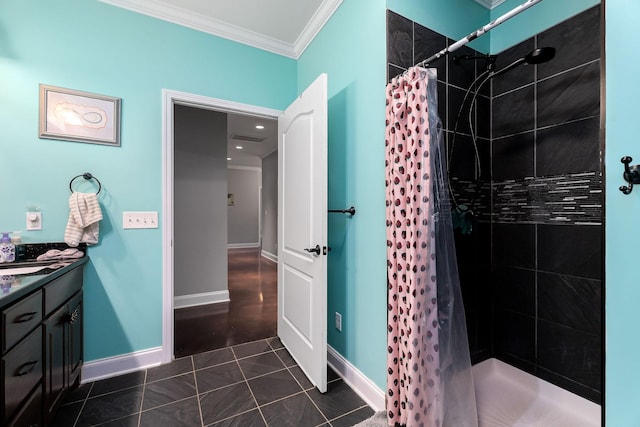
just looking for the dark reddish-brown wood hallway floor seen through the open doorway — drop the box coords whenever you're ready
[174,248,278,358]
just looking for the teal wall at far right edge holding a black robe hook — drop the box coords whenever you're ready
[605,0,640,427]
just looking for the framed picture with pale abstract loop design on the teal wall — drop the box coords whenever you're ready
[38,84,121,146]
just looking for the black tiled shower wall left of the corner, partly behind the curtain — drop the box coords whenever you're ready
[387,11,492,363]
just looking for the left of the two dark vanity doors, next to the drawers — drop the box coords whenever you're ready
[44,304,69,420]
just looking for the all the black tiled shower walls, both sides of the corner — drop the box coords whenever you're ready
[387,6,603,402]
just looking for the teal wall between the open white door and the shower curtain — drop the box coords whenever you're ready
[298,0,387,389]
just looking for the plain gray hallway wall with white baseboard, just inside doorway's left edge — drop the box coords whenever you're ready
[174,105,228,307]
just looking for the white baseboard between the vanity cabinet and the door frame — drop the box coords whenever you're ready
[81,347,162,384]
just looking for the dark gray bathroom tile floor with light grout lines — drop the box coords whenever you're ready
[54,338,374,427]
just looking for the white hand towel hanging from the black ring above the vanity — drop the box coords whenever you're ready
[64,192,102,247]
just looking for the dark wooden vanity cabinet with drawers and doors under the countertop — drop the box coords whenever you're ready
[0,261,86,427]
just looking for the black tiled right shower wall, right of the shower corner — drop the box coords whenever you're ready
[491,6,603,403]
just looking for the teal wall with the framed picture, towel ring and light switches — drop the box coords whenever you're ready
[0,0,296,361]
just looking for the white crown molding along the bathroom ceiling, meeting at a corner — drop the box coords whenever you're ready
[98,0,342,59]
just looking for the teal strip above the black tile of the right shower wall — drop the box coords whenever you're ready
[485,0,600,53]
